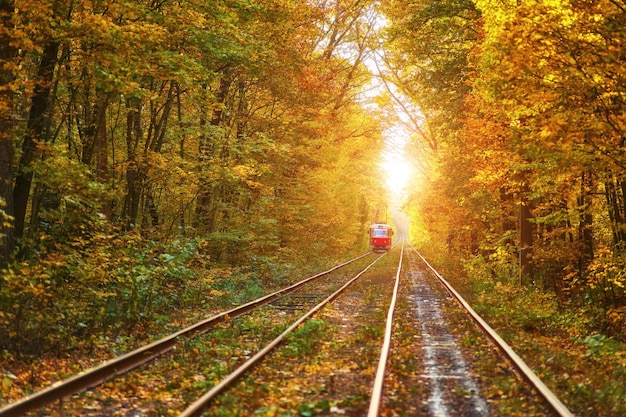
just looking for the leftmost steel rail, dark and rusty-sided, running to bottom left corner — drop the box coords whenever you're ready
[0,252,371,417]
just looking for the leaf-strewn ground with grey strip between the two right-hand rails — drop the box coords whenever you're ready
[392,256,553,417]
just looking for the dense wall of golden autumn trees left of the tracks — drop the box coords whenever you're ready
[0,0,383,354]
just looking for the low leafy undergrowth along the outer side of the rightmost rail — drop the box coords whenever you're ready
[450,252,626,416]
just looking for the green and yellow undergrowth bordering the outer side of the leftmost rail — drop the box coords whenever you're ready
[0,231,302,402]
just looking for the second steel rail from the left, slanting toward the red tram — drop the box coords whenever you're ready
[178,252,387,417]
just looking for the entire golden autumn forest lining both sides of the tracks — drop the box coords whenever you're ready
[0,0,626,364]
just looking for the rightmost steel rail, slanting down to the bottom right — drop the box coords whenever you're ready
[409,243,574,417]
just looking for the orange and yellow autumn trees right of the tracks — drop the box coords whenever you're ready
[383,0,626,332]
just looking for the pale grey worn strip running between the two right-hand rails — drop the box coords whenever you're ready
[409,268,489,417]
